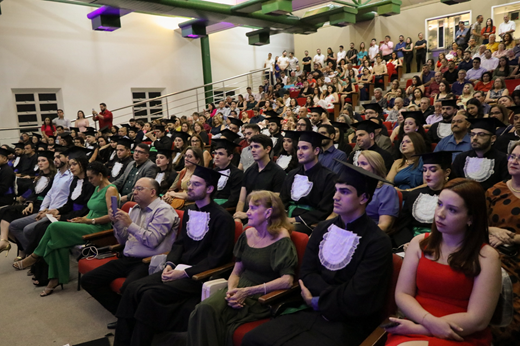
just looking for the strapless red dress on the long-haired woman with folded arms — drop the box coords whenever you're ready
[386,246,492,346]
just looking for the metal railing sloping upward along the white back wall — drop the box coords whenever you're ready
[0,68,269,142]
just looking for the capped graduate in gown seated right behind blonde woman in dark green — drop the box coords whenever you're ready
[280,131,336,235]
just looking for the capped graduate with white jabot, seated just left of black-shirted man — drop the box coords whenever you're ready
[213,139,244,208]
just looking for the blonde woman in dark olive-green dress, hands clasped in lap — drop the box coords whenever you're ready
[188,191,298,346]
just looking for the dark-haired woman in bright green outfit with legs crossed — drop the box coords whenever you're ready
[13,161,118,297]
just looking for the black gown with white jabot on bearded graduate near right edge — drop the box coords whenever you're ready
[450,147,511,191]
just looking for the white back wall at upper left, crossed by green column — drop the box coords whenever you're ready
[0,0,293,143]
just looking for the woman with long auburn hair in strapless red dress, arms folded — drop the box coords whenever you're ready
[386,179,502,346]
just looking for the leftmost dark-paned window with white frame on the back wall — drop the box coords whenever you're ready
[13,89,60,132]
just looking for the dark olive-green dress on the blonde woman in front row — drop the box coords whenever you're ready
[188,232,298,346]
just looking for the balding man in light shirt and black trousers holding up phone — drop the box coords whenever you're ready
[81,178,180,329]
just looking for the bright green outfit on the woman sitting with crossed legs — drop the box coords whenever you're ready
[34,184,115,284]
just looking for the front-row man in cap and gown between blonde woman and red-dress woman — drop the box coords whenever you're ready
[242,162,392,346]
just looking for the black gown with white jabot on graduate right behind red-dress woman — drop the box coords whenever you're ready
[392,186,440,246]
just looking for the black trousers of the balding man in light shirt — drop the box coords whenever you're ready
[81,257,148,315]
